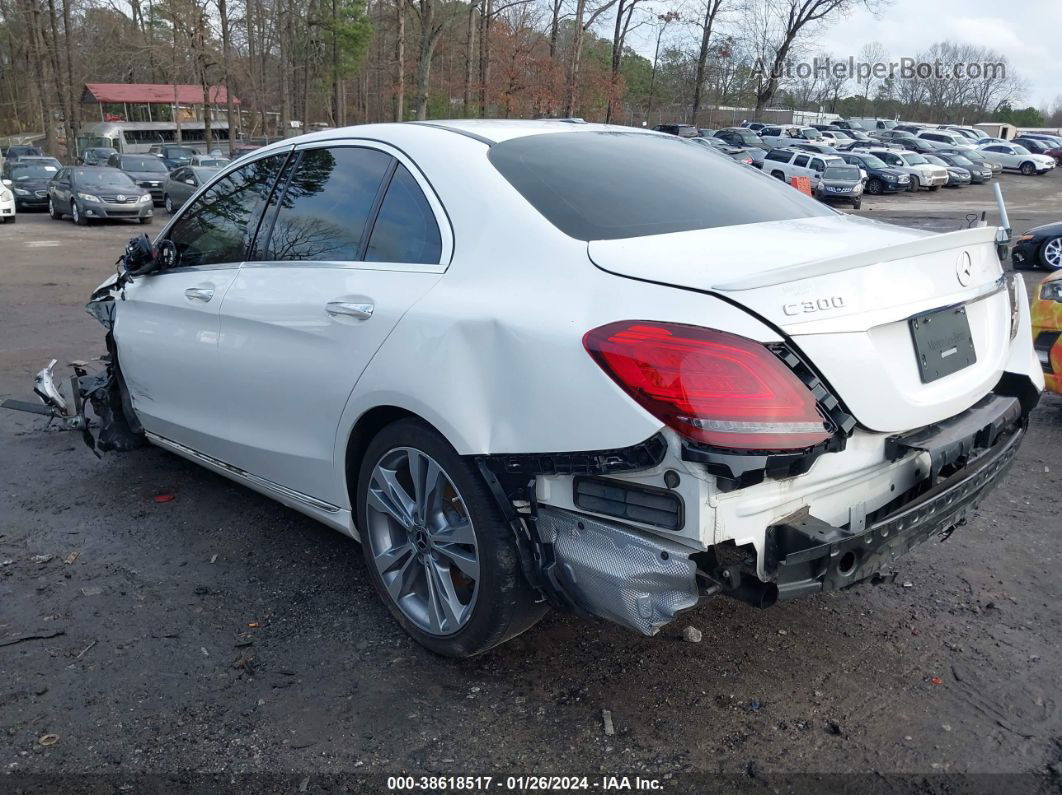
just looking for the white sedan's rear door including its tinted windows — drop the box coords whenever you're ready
[219,140,452,507]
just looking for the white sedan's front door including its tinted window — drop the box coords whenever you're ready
[115,154,286,456]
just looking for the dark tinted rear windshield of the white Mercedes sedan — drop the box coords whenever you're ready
[489,133,834,240]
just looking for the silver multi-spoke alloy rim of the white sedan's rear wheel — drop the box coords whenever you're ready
[362,447,479,636]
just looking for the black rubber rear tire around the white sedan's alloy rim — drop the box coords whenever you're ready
[356,418,547,657]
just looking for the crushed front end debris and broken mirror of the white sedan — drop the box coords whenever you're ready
[0,245,147,456]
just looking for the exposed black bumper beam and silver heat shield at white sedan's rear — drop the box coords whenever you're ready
[532,395,1027,635]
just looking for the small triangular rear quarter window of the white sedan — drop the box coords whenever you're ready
[365,165,443,264]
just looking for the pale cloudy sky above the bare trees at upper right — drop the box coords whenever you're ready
[628,0,1062,108]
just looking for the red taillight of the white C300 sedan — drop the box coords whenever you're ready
[583,321,829,450]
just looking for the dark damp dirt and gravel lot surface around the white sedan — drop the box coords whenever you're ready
[0,173,1062,792]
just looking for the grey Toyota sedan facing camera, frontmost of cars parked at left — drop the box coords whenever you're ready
[48,166,154,226]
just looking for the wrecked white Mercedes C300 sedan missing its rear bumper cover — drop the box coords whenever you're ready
[10,121,1043,656]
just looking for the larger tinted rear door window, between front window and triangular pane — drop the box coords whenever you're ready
[264,146,392,262]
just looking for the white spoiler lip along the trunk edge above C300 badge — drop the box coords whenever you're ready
[710,226,999,293]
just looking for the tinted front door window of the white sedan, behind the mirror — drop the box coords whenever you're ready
[164,153,287,267]
